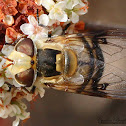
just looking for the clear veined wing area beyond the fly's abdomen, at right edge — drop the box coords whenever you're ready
[96,33,126,98]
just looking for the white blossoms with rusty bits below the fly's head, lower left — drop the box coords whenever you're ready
[0,80,44,126]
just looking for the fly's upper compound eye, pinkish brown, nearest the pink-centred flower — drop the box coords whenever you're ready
[15,38,34,57]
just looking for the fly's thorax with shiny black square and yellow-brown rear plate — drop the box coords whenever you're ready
[37,43,77,83]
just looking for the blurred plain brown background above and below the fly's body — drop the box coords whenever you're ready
[0,0,126,126]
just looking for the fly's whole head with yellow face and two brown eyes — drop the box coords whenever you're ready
[6,38,36,87]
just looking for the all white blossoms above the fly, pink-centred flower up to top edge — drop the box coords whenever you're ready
[20,0,88,39]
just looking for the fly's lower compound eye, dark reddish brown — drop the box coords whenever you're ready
[15,68,35,87]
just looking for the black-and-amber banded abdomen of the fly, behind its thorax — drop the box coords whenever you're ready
[62,35,104,93]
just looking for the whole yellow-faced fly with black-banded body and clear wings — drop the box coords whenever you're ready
[3,22,126,99]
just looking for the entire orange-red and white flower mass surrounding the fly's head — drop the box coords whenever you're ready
[0,0,88,126]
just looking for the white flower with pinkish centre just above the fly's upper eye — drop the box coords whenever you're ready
[20,15,48,39]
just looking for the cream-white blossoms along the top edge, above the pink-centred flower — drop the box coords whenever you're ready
[36,0,88,25]
